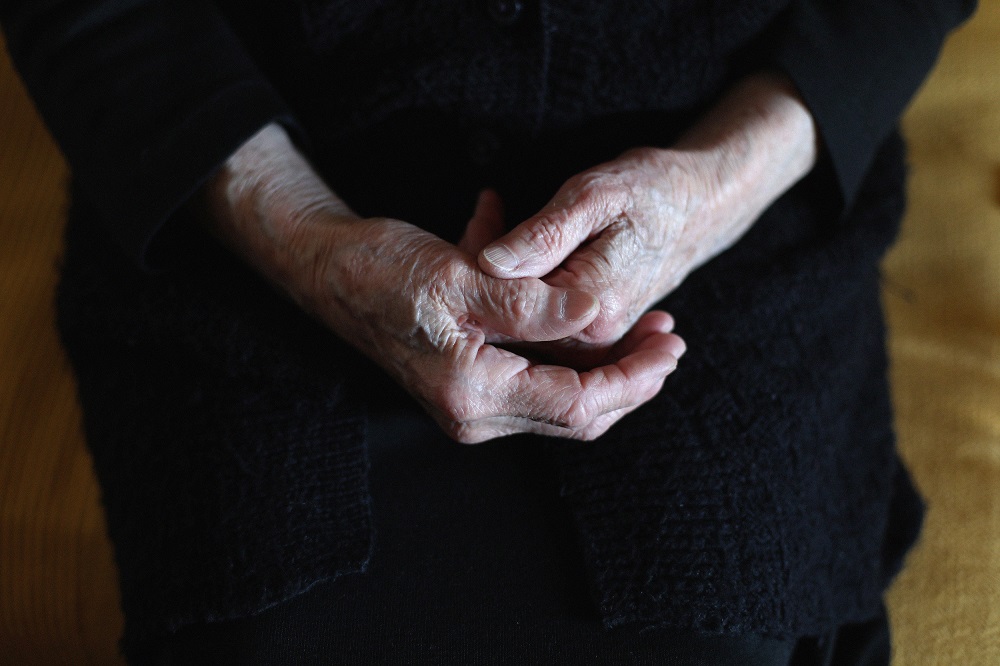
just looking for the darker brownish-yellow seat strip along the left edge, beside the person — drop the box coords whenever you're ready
[0,39,124,666]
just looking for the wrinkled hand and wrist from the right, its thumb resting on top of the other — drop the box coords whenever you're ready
[479,73,816,349]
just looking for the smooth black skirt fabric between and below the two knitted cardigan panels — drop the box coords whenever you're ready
[136,396,811,666]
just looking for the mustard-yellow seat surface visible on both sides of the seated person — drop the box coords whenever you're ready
[0,0,1000,666]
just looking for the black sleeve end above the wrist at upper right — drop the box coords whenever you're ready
[772,0,976,210]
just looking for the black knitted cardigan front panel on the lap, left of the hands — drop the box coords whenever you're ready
[58,204,371,649]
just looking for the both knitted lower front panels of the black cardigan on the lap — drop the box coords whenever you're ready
[60,123,920,646]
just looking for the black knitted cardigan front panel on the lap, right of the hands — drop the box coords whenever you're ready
[553,132,920,637]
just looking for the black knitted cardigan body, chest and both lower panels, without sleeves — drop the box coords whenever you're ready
[41,0,952,645]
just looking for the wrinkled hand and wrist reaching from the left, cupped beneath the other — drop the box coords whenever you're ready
[207,123,684,443]
